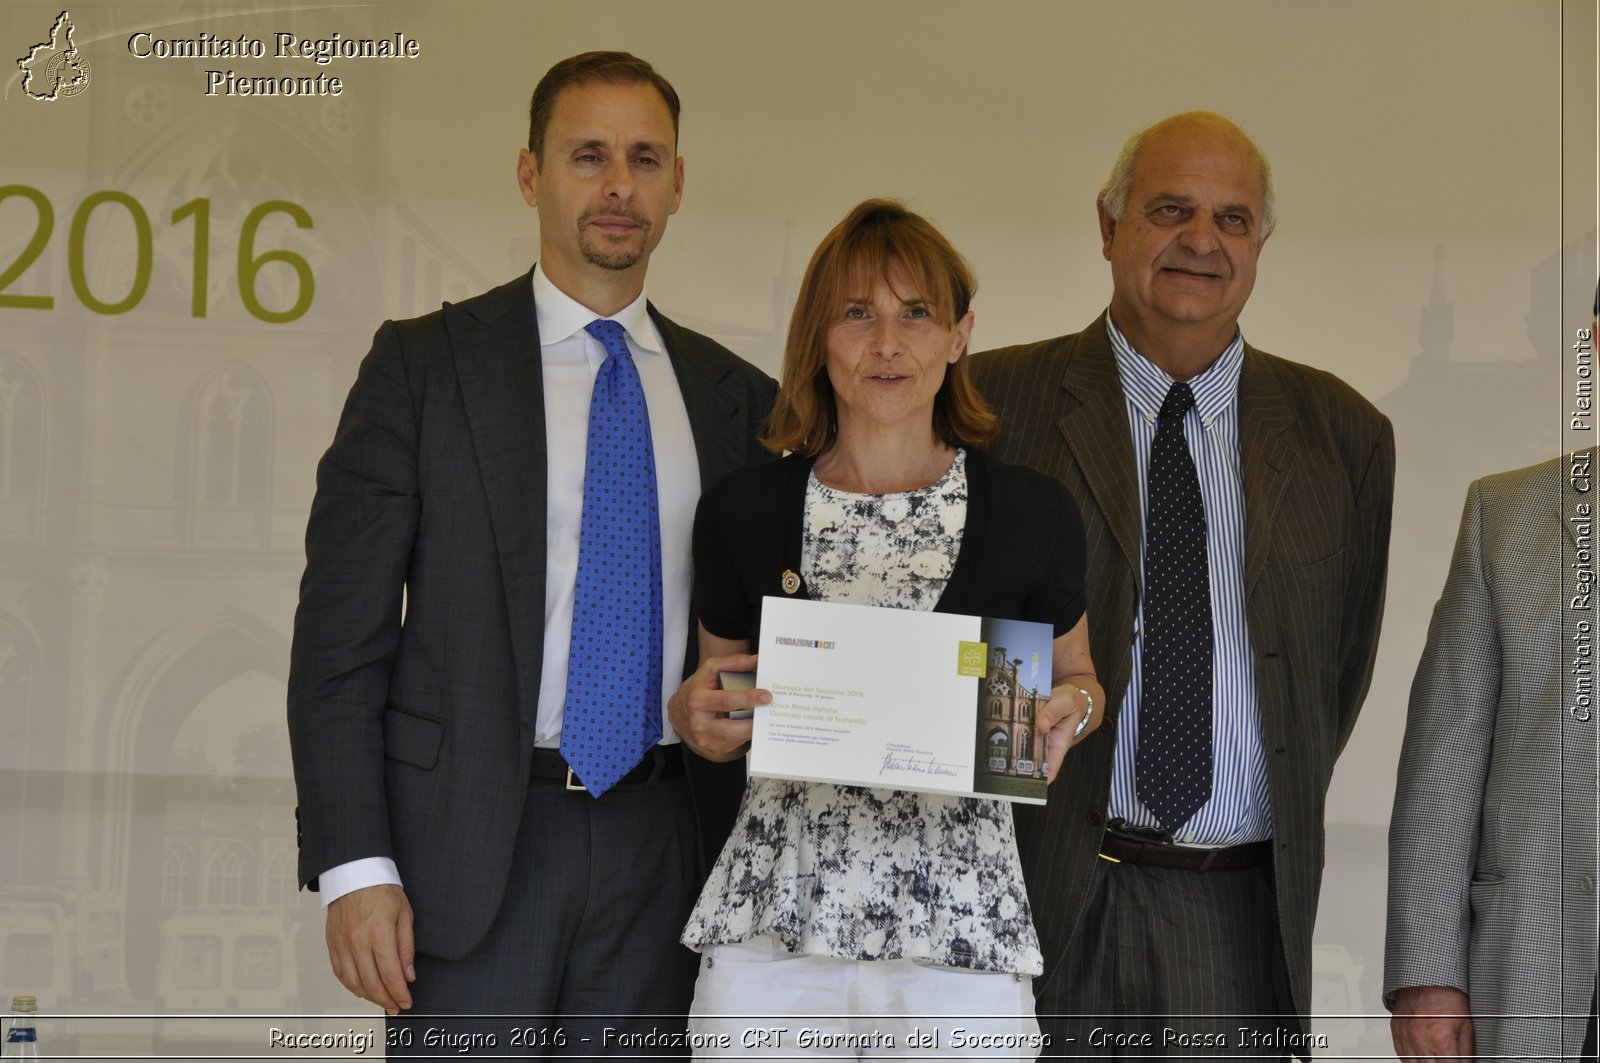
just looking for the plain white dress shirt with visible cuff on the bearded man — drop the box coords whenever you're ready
[318,266,701,908]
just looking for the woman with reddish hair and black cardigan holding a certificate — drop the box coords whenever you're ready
[672,200,1104,1058]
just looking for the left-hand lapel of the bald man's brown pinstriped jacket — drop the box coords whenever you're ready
[1059,314,1139,580]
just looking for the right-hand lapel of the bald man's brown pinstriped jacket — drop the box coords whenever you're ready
[1238,344,1298,599]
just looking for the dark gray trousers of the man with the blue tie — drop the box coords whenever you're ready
[387,776,699,1060]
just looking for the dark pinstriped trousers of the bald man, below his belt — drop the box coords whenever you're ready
[1038,860,1301,1058]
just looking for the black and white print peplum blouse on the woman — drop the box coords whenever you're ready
[683,450,1043,975]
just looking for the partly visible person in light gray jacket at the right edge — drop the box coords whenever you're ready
[1384,450,1597,1060]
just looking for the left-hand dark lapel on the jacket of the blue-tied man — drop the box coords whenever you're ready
[445,274,547,726]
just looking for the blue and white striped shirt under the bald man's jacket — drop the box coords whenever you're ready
[1106,311,1272,845]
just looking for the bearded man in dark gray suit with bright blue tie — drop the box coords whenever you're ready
[290,53,776,1055]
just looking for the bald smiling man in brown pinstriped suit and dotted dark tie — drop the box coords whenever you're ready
[971,112,1394,1055]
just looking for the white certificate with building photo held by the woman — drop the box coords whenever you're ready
[749,597,1053,805]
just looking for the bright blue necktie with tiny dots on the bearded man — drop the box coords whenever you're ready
[562,320,662,797]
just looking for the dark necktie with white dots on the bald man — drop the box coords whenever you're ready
[1133,384,1211,832]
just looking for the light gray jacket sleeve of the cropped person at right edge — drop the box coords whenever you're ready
[1384,483,1501,1009]
